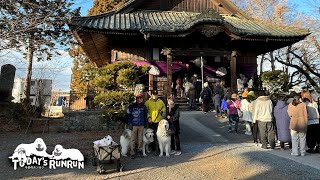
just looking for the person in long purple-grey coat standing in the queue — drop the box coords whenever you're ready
[273,98,291,149]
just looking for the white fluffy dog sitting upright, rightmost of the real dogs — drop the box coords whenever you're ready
[157,119,171,157]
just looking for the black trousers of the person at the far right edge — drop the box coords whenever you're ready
[306,124,320,149]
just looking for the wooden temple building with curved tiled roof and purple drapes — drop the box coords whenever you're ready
[69,0,310,95]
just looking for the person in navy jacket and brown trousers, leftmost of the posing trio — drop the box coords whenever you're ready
[127,94,148,159]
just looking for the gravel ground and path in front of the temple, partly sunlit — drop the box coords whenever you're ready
[0,112,320,180]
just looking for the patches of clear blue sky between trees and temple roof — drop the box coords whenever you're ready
[0,0,319,91]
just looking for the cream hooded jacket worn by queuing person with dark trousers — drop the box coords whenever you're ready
[252,96,273,123]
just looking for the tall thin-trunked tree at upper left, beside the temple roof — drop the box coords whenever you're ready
[0,0,79,106]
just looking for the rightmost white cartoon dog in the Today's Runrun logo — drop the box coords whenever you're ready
[52,144,84,161]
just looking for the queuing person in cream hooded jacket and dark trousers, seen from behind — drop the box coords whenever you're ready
[252,91,276,149]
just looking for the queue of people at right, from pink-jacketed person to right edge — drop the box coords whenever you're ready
[225,89,320,156]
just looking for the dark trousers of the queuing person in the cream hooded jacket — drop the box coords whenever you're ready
[257,121,276,149]
